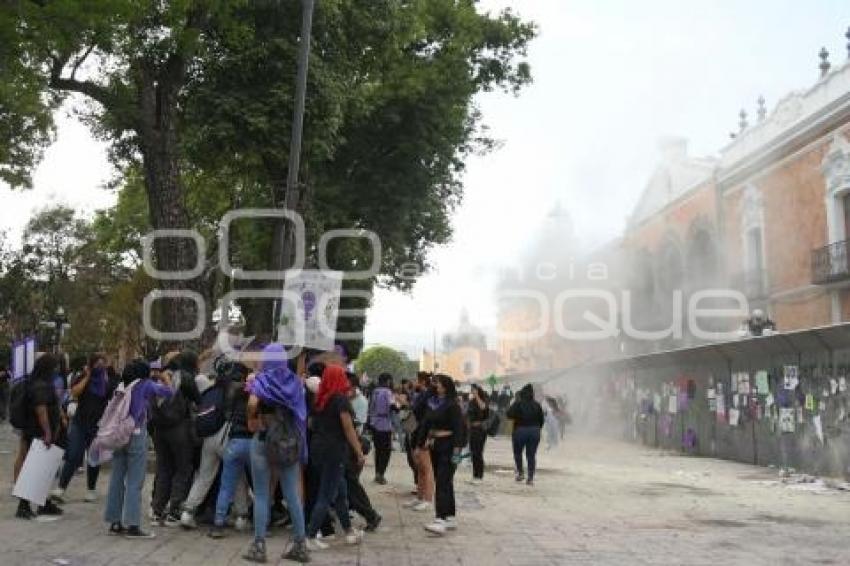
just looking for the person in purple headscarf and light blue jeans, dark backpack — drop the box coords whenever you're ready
[240,344,310,562]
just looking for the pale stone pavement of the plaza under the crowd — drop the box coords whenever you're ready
[0,425,850,566]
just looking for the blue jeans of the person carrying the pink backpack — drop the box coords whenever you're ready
[104,428,148,527]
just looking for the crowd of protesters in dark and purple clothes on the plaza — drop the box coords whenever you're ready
[6,344,565,562]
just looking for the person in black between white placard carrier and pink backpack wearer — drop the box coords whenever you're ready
[53,354,119,503]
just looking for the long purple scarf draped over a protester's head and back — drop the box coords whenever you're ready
[248,344,307,464]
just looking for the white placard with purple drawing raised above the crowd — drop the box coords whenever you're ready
[278,270,342,351]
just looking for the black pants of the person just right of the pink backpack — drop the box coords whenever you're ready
[153,422,194,516]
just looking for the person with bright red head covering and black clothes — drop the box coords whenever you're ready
[307,365,366,550]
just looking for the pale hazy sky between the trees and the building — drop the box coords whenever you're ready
[0,0,850,357]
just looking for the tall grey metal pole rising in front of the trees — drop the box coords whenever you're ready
[272,0,315,337]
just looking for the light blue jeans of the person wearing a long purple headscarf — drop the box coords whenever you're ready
[248,434,304,542]
